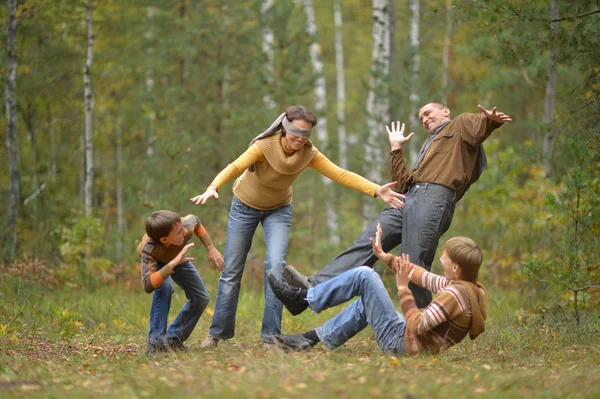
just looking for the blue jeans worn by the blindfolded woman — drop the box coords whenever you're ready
[209,196,292,342]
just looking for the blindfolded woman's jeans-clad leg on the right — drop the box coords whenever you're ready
[260,204,292,342]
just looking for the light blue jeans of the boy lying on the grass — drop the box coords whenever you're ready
[307,266,406,354]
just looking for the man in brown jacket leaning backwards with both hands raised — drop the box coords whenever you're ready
[284,102,512,308]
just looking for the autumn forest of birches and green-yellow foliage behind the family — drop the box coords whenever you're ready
[0,0,600,398]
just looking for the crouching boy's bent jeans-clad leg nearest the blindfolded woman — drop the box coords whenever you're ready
[165,262,210,345]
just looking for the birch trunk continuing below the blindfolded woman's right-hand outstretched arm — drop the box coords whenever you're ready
[304,0,340,245]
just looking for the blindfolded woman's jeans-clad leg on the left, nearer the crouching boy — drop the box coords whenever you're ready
[208,197,260,339]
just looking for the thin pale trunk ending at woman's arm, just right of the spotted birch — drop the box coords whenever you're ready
[333,0,348,169]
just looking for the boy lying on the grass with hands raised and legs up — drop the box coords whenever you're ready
[268,225,488,355]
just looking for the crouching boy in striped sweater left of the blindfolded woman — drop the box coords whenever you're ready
[137,211,225,354]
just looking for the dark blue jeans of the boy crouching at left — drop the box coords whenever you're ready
[148,262,210,345]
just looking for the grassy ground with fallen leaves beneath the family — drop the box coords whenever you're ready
[0,280,600,398]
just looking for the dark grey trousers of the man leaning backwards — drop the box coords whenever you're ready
[309,183,455,308]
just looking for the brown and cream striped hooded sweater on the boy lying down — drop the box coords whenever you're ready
[385,254,487,354]
